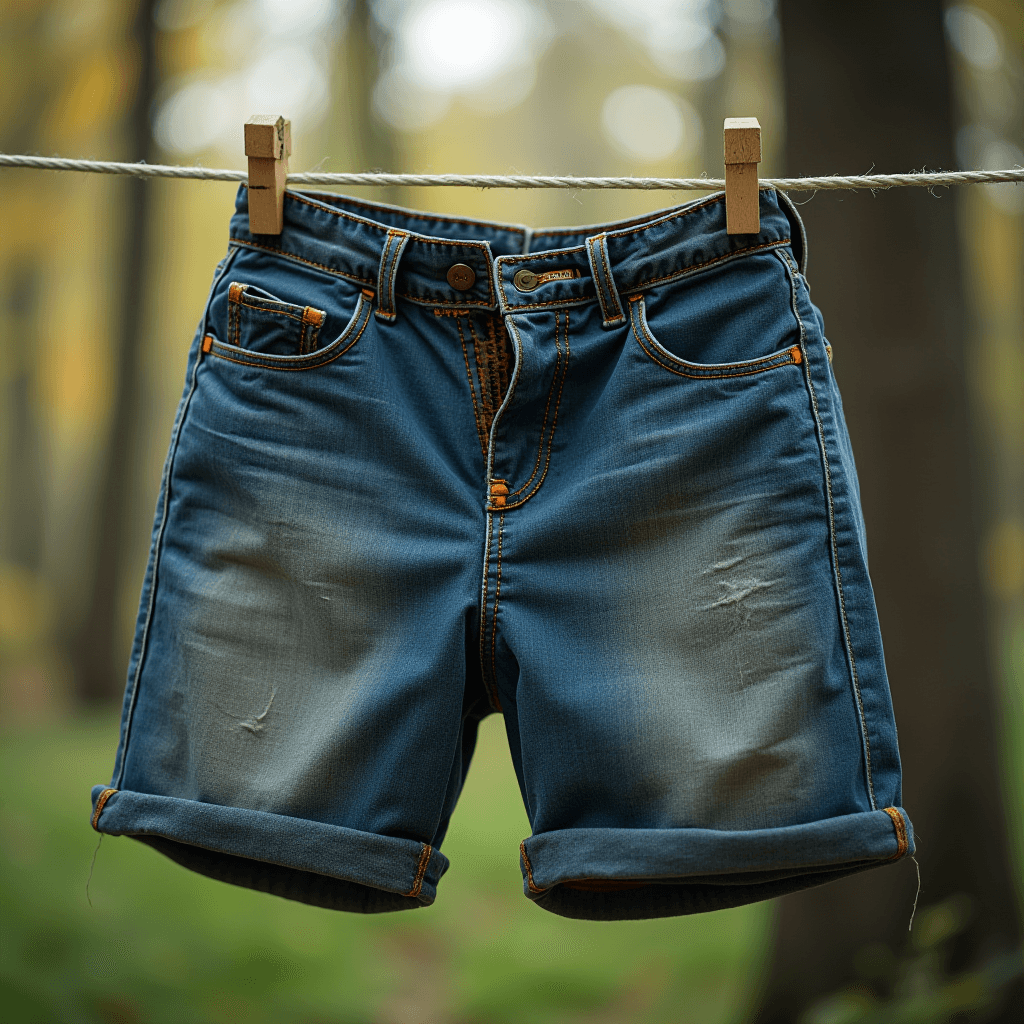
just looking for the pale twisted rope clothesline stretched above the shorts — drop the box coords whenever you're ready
[0,153,1024,191]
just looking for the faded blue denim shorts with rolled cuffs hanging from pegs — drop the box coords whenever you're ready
[92,187,914,920]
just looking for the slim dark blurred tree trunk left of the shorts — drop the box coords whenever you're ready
[68,0,158,702]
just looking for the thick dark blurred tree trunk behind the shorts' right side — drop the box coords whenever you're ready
[756,0,1024,1024]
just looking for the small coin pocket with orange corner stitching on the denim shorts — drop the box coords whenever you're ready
[227,282,327,355]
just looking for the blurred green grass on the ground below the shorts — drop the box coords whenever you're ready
[0,716,770,1024]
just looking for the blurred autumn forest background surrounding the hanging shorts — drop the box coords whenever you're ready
[0,0,1024,1024]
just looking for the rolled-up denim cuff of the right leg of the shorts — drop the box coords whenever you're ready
[520,807,914,921]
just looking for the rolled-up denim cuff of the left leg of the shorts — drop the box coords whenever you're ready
[92,785,449,913]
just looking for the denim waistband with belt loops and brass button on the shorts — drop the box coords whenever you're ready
[230,184,807,325]
